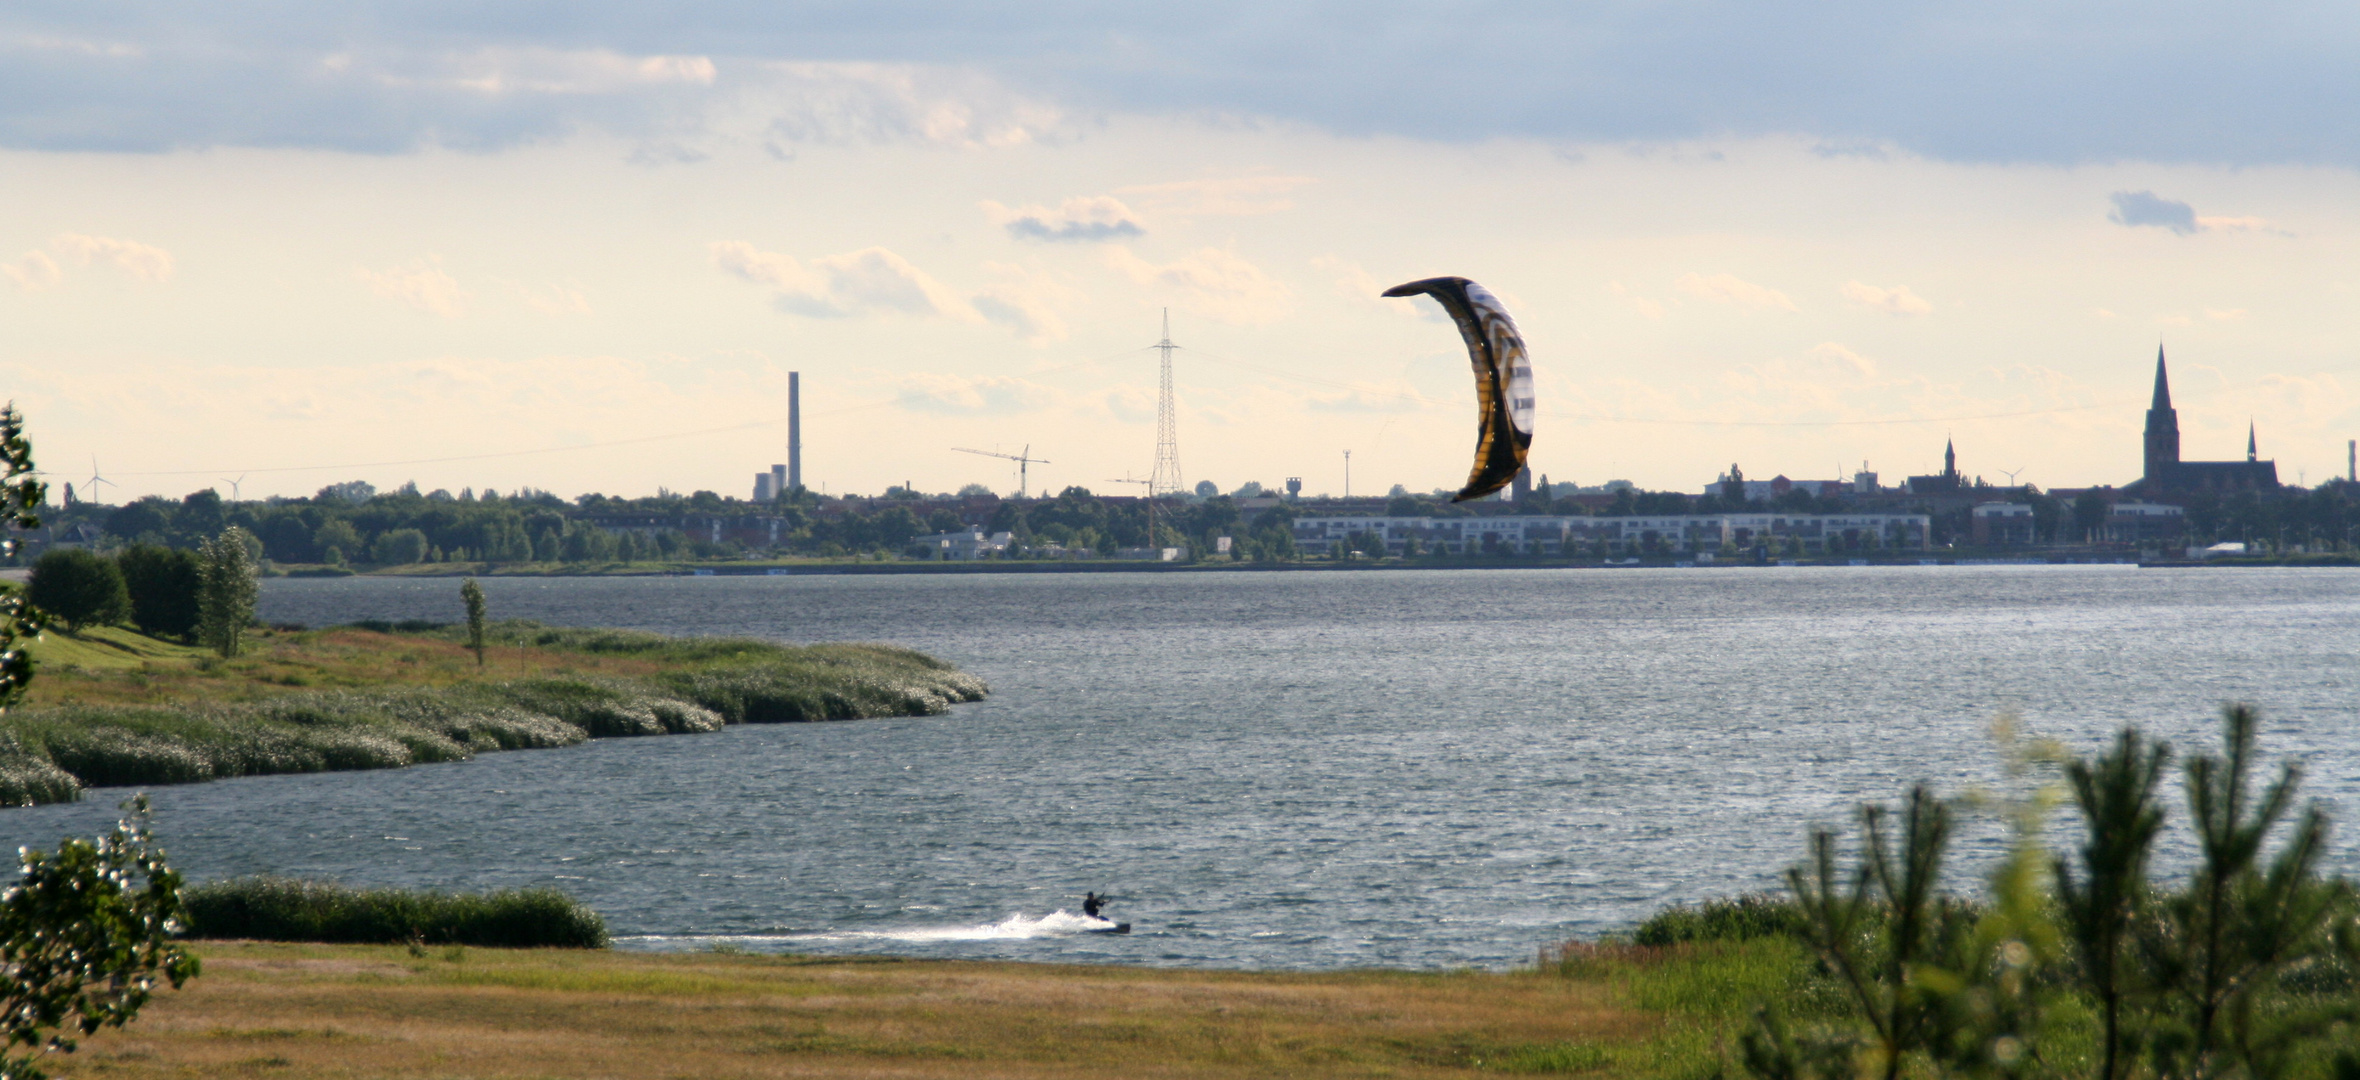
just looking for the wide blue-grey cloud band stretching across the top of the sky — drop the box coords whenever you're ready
[13,0,2360,167]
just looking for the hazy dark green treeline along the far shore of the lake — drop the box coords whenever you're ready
[50,471,2360,566]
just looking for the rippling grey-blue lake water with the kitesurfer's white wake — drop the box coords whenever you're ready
[0,566,2360,969]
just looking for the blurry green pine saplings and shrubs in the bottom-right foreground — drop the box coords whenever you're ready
[1739,705,2360,1080]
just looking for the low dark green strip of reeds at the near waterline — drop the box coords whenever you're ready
[182,877,607,948]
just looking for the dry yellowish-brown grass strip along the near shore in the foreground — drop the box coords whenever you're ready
[73,941,1803,1080]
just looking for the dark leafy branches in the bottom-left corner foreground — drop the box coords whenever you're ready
[0,795,198,1080]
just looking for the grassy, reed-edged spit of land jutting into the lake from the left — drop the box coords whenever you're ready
[0,623,984,804]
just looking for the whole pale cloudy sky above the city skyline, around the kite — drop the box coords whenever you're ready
[0,0,2360,502]
